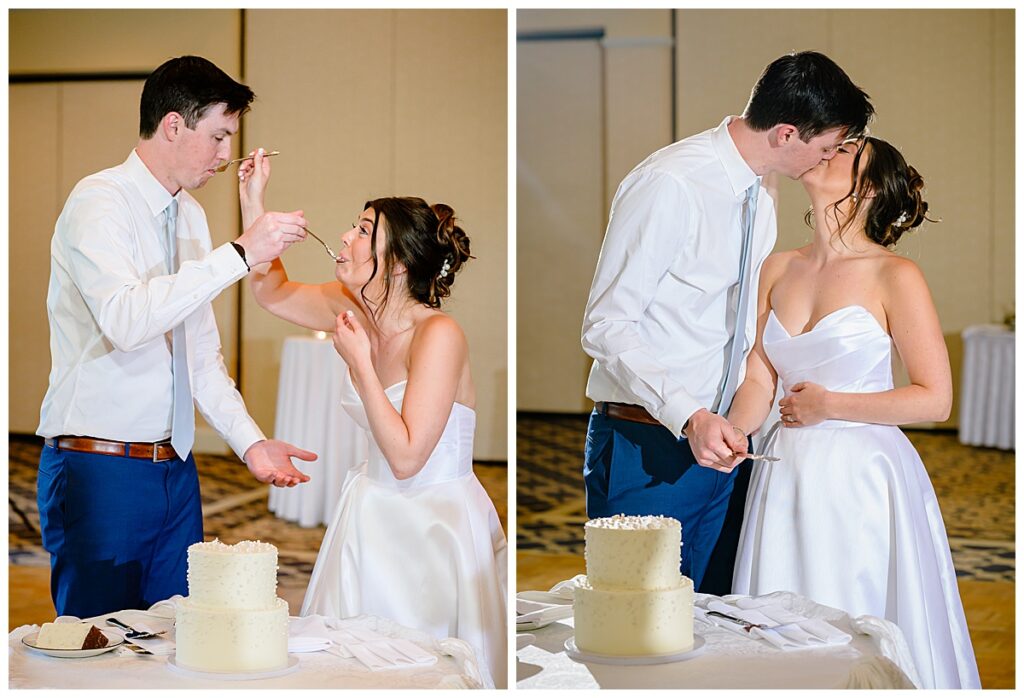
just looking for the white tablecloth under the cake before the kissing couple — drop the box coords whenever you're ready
[516,592,915,689]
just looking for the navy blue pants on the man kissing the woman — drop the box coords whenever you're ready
[583,409,738,588]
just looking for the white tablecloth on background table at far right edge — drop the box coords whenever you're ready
[959,324,1015,448]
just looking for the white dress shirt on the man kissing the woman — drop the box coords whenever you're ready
[583,117,776,435]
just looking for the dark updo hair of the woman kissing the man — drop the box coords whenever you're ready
[808,136,935,248]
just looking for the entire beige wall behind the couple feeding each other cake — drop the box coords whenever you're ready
[9,10,508,460]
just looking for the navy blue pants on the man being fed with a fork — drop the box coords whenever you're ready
[37,446,203,618]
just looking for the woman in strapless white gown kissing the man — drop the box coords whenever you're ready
[729,137,980,688]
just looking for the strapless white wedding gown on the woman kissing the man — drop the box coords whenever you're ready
[733,305,981,688]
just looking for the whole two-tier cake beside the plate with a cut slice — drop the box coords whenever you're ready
[174,540,288,673]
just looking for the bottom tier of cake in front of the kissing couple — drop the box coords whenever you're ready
[572,576,693,657]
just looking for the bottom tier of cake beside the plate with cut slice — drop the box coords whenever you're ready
[174,598,288,673]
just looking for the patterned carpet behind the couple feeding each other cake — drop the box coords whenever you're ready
[7,435,508,587]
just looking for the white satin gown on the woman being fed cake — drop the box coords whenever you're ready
[301,373,508,688]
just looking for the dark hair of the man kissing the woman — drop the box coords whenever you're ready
[743,51,874,142]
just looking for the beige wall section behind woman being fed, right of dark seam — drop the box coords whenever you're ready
[242,10,508,460]
